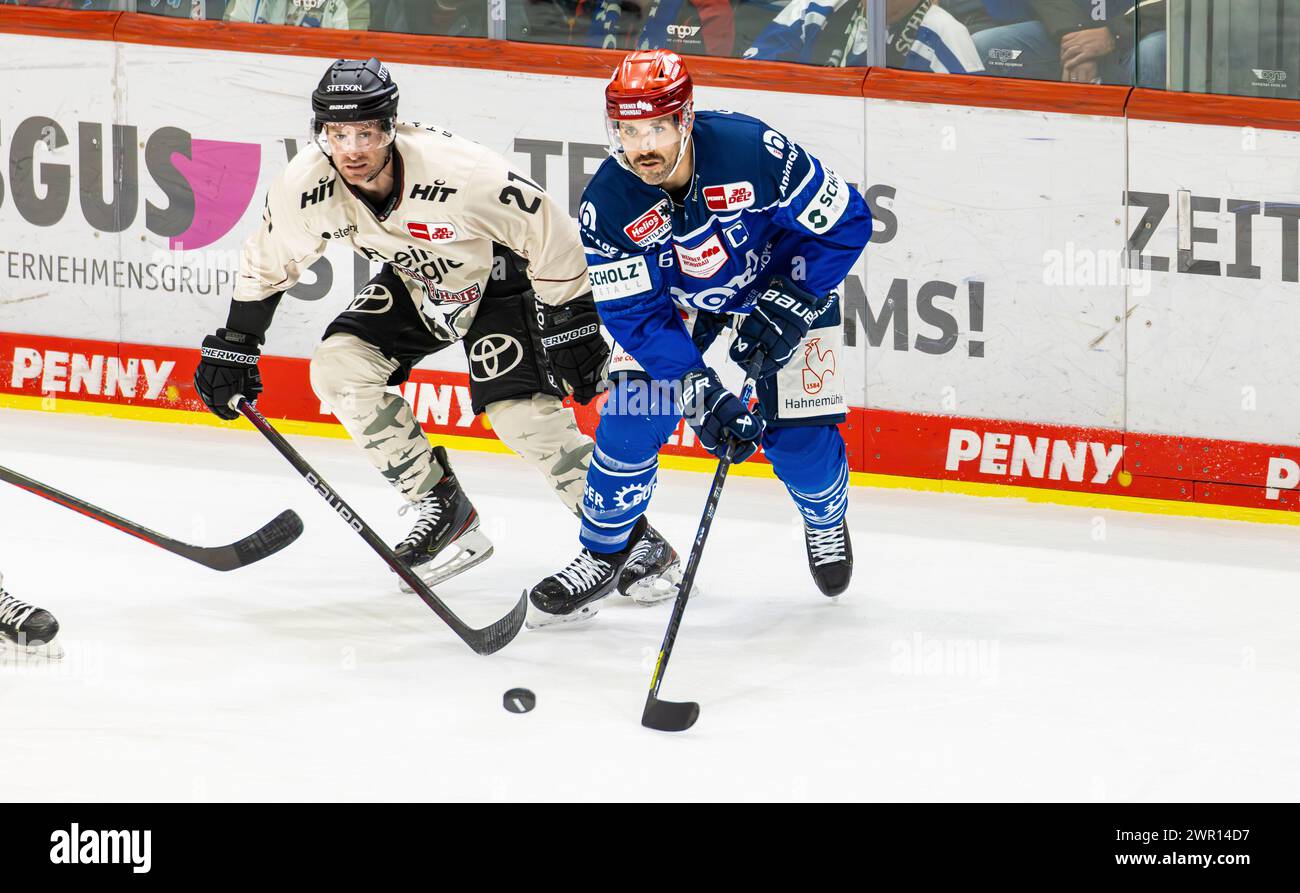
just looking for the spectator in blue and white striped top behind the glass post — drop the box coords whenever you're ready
[744,0,984,74]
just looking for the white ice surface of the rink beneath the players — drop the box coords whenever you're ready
[0,411,1300,801]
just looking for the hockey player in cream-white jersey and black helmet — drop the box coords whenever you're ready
[195,58,676,590]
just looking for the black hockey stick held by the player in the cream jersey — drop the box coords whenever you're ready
[239,396,528,654]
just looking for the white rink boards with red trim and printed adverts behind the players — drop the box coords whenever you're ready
[0,17,1300,521]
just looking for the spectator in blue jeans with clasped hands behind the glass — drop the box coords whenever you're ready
[966,0,1166,90]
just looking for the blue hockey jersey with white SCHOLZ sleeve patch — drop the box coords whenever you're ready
[579,112,871,380]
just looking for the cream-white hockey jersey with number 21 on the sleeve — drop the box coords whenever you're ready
[234,123,589,341]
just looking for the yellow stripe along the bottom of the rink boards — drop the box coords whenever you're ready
[10,394,1300,526]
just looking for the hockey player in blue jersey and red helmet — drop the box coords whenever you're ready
[529,49,871,627]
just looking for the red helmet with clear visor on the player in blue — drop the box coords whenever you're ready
[605,49,696,182]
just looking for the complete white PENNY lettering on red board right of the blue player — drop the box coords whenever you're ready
[944,428,1125,484]
